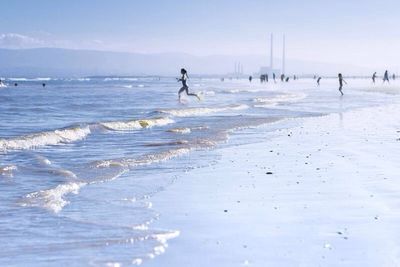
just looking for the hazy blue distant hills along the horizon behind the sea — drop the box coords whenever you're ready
[0,48,371,77]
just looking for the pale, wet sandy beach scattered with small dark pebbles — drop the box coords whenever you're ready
[145,105,400,266]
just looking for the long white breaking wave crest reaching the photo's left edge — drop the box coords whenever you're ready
[0,126,90,152]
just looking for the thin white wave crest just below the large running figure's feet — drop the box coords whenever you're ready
[159,104,249,117]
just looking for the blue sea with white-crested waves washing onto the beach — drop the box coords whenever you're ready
[0,76,399,266]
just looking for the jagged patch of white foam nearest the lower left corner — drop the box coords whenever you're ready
[20,182,86,213]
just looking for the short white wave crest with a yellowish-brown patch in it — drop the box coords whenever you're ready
[100,118,174,131]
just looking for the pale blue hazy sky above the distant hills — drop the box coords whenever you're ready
[0,0,400,68]
